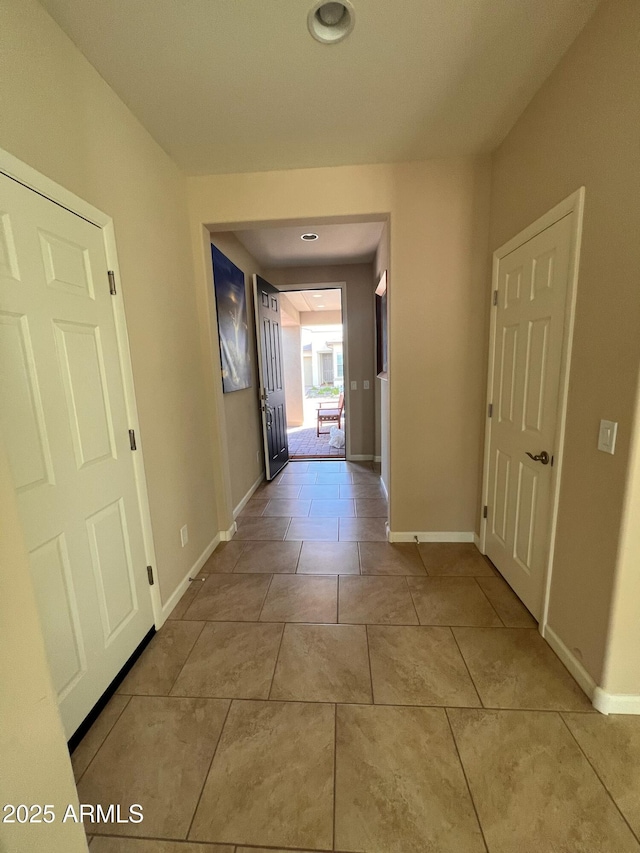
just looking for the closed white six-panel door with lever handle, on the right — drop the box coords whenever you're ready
[485,215,572,619]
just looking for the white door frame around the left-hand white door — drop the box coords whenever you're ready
[0,148,164,628]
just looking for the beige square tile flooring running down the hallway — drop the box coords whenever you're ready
[73,463,640,853]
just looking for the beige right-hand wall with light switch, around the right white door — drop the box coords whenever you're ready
[491,0,640,693]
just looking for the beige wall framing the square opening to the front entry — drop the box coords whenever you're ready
[188,158,489,531]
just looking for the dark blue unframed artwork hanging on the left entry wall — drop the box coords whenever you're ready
[211,244,251,394]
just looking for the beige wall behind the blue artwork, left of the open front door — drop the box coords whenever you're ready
[205,232,264,509]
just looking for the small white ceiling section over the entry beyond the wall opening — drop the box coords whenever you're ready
[235,222,383,267]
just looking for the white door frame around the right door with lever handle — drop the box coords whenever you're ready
[479,187,585,634]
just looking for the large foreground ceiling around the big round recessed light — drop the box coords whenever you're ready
[41,0,598,175]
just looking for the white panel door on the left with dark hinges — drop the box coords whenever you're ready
[0,175,153,737]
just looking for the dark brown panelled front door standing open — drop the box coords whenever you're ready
[253,275,289,480]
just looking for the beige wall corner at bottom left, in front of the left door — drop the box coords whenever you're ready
[0,437,87,853]
